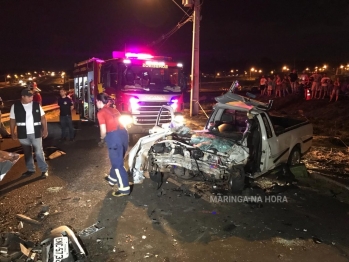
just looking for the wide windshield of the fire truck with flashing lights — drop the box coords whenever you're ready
[121,65,182,93]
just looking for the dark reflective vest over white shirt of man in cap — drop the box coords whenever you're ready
[14,101,42,139]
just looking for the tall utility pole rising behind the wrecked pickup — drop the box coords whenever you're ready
[182,0,201,116]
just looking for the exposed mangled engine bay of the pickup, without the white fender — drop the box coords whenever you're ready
[148,130,249,180]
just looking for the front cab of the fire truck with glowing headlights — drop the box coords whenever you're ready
[101,52,187,134]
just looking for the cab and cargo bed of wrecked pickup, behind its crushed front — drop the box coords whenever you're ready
[205,83,313,177]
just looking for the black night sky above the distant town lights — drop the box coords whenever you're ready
[0,0,349,71]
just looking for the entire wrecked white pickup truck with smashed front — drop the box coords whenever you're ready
[128,83,313,192]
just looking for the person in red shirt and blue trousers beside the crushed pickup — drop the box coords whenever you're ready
[96,93,130,197]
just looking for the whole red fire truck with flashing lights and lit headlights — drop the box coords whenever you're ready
[74,52,187,134]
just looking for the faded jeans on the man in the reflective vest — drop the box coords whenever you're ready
[18,134,47,172]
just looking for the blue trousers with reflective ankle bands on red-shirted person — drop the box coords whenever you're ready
[105,129,130,194]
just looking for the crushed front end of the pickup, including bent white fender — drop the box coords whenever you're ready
[129,105,249,190]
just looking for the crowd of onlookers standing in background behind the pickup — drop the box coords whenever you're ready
[259,70,349,102]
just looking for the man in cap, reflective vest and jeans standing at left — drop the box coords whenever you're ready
[10,88,48,178]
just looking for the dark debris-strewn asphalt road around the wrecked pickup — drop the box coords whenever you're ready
[0,111,349,262]
